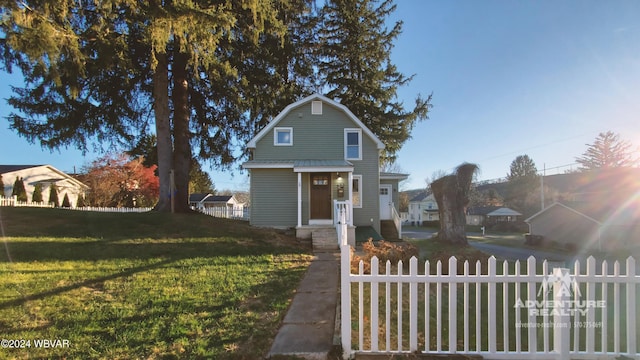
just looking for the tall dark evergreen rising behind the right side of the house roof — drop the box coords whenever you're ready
[318,0,431,161]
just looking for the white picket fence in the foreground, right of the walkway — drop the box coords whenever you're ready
[341,252,640,359]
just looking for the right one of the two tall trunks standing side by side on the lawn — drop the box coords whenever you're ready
[172,36,191,212]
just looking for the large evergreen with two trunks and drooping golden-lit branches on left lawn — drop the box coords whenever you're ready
[0,0,292,211]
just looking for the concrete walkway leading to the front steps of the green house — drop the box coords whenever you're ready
[268,252,340,360]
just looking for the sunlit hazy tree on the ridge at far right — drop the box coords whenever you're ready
[576,131,638,171]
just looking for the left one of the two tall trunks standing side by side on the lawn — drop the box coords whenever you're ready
[153,53,173,212]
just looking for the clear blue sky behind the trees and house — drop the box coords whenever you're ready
[0,0,640,190]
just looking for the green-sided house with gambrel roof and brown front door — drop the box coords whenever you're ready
[242,94,407,243]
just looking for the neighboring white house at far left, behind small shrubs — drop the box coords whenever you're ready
[0,165,89,207]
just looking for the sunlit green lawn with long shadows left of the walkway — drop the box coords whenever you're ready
[0,208,310,359]
